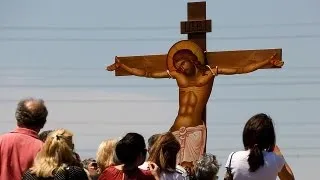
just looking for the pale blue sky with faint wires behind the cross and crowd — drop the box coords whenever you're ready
[0,0,320,179]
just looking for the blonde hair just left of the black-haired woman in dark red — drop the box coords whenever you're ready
[96,139,118,172]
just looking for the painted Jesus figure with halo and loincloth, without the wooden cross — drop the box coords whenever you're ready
[106,40,283,167]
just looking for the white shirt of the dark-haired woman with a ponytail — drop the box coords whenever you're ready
[225,150,285,180]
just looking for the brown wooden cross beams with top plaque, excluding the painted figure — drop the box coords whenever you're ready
[111,2,282,123]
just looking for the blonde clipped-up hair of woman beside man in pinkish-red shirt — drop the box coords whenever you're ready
[30,129,77,178]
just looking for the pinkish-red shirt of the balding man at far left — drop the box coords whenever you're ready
[0,128,43,180]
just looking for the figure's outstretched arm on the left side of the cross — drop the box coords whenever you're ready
[106,57,173,78]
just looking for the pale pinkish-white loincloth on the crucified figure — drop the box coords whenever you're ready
[172,125,206,164]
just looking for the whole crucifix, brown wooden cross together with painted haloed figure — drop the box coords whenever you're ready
[106,2,283,168]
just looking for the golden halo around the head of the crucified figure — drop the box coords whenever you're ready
[167,40,205,71]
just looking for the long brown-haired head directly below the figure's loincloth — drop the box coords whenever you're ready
[148,132,180,171]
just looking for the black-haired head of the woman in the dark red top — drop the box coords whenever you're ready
[116,133,147,168]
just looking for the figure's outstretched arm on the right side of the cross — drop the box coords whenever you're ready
[217,54,284,75]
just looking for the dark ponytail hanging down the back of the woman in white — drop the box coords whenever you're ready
[248,144,264,172]
